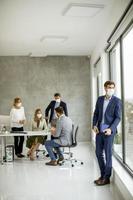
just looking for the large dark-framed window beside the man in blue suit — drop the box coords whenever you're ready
[109,23,133,174]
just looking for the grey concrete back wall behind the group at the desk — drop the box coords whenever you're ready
[0,57,90,141]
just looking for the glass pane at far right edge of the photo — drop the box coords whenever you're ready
[123,28,133,169]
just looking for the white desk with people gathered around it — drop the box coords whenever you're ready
[0,131,51,164]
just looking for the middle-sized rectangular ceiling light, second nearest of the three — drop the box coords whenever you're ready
[40,35,68,42]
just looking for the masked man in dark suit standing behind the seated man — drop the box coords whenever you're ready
[45,93,68,126]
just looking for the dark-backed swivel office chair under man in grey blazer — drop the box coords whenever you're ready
[60,125,84,167]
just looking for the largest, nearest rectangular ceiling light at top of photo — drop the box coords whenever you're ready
[63,3,104,17]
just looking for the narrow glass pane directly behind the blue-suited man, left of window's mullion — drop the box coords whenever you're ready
[110,43,123,158]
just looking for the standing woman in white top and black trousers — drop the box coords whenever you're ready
[10,97,26,158]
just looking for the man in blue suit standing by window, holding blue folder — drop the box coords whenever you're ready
[93,81,122,186]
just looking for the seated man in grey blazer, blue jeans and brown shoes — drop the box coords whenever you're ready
[45,107,72,166]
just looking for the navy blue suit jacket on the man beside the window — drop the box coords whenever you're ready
[93,96,122,134]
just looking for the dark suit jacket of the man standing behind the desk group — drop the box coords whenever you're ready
[45,101,68,122]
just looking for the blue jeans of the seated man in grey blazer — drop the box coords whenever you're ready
[45,140,63,160]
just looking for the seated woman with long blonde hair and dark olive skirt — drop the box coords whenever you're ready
[26,108,47,160]
